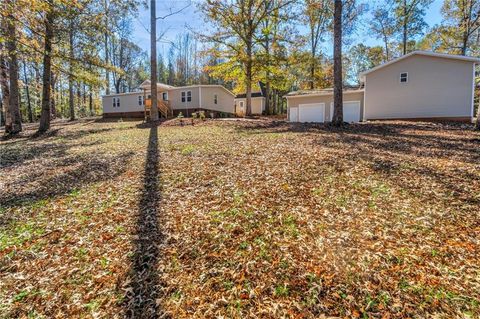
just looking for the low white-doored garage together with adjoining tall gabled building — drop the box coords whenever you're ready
[285,51,480,122]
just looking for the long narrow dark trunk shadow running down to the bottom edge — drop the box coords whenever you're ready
[125,125,167,318]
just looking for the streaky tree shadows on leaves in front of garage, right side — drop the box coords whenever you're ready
[236,121,480,205]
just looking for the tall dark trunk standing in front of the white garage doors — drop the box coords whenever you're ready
[332,0,343,126]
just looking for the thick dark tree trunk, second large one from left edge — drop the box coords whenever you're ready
[38,4,53,133]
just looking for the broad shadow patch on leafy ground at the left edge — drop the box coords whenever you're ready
[0,124,139,208]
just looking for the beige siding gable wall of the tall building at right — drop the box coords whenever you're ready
[365,55,473,120]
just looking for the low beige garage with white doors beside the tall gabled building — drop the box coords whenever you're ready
[285,87,363,123]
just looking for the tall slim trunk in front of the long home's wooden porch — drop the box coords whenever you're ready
[150,0,159,121]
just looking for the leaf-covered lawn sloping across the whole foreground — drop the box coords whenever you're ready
[0,120,480,318]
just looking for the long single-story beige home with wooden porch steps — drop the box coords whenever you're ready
[102,80,235,117]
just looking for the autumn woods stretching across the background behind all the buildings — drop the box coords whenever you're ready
[0,0,480,134]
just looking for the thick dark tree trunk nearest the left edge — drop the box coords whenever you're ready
[6,4,22,134]
